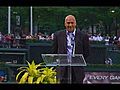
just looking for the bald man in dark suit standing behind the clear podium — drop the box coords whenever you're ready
[52,15,89,84]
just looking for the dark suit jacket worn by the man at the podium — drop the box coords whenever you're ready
[52,29,89,82]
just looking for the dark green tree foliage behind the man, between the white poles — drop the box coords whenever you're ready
[0,6,120,33]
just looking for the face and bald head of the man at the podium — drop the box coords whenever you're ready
[65,16,76,32]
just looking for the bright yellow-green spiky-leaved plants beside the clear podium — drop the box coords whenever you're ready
[16,60,58,84]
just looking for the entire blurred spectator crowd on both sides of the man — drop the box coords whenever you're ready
[0,32,120,48]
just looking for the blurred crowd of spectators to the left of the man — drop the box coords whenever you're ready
[0,32,53,48]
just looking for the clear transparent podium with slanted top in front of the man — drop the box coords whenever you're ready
[41,54,87,84]
